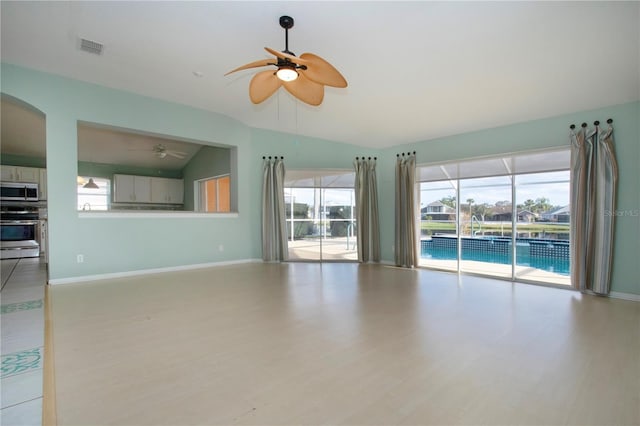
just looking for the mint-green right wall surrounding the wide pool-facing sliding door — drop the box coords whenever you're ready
[378,102,640,294]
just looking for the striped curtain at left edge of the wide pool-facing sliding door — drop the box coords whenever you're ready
[395,153,419,268]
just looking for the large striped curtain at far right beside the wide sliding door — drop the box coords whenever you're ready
[570,124,618,295]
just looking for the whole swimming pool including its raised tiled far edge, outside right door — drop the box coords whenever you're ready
[420,238,570,276]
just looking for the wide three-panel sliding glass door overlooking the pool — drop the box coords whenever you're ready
[418,149,570,284]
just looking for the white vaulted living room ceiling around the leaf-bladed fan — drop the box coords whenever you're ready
[0,1,640,148]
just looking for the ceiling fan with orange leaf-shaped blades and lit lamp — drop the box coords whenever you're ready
[225,16,347,106]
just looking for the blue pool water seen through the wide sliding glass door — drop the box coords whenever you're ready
[421,243,570,275]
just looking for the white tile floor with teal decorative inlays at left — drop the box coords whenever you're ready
[0,258,47,426]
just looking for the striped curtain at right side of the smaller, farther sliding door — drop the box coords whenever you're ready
[353,157,380,262]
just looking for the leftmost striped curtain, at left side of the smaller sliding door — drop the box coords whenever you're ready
[262,158,289,262]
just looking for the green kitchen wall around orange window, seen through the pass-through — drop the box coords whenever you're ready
[182,146,236,211]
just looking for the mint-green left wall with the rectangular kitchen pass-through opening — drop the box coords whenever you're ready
[0,64,254,280]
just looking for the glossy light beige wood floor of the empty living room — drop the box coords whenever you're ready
[50,263,640,425]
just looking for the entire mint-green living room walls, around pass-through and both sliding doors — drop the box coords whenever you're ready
[0,64,640,294]
